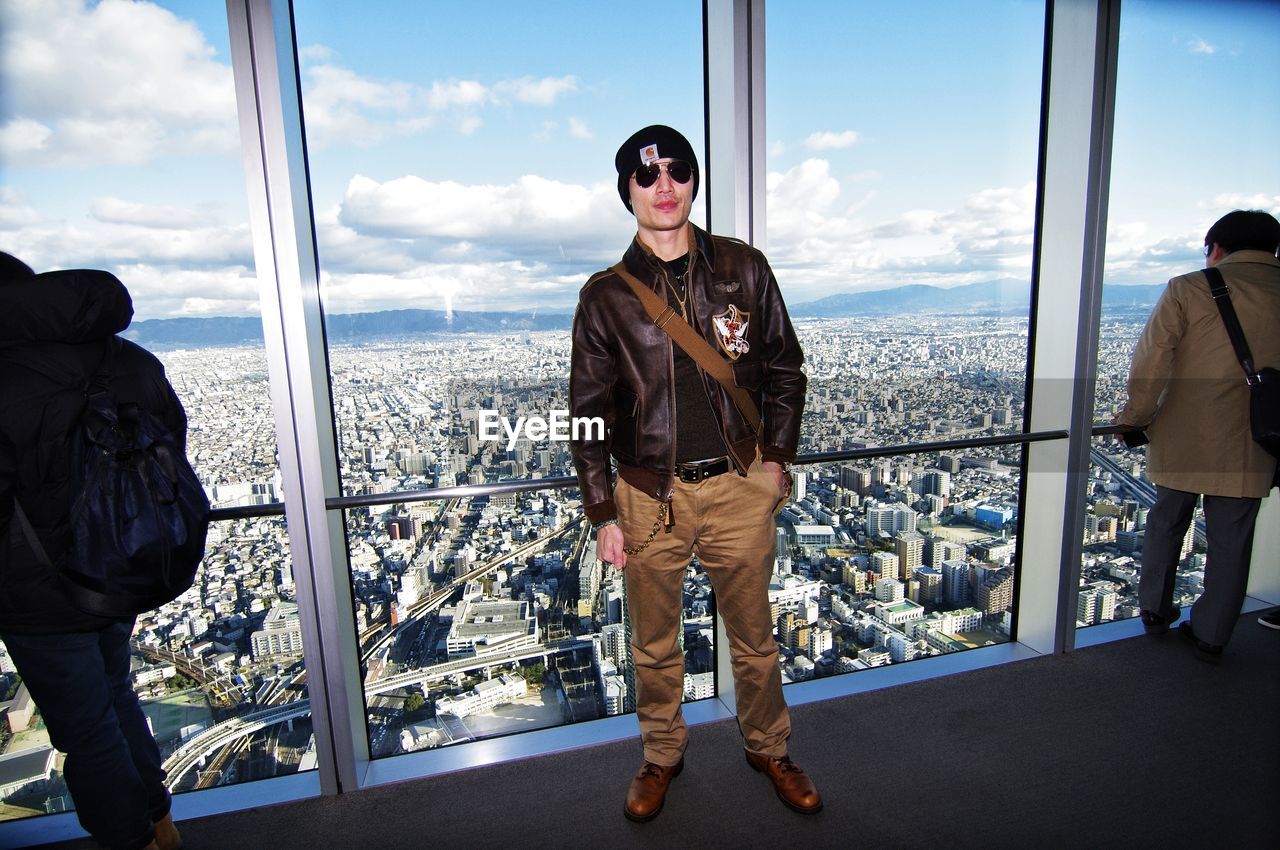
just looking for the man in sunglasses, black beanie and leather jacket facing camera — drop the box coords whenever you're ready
[570,125,822,821]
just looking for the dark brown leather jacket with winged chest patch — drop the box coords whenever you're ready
[570,225,806,524]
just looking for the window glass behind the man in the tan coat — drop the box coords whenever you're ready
[1076,0,1280,626]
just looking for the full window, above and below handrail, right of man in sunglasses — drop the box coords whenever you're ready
[765,0,1044,680]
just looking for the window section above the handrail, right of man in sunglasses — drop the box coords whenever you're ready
[765,0,1044,451]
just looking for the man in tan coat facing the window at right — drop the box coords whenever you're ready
[1116,210,1280,661]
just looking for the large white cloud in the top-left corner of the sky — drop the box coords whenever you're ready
[0,0,237,166]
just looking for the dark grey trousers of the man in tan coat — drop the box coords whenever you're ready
[1138,486,1262,646]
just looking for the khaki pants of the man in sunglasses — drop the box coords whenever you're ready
[613,461,791,766]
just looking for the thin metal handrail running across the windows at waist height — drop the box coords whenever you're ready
[210,425,1075,522]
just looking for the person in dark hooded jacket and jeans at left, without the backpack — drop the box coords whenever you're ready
[0,253,187,850]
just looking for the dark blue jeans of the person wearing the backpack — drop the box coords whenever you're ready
[3,622,169,850]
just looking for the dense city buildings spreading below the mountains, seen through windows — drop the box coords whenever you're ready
[0,307,1198,809]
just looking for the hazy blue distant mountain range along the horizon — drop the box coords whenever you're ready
[123,280,1165,349]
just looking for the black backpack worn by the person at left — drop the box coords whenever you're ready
[14,337,209,618]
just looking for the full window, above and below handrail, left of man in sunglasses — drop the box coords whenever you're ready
[294,0,713,755]
